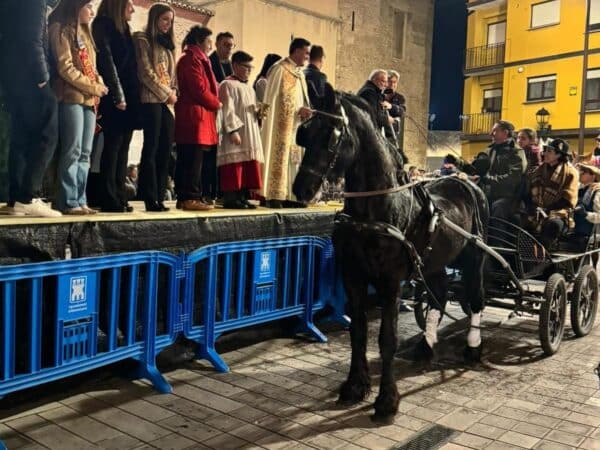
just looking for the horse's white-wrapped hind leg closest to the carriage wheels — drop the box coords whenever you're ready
[462,249,485,362]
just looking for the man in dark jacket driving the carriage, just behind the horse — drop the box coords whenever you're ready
[472,120,527,221]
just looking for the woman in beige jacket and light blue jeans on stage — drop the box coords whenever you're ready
[48,0,108,215]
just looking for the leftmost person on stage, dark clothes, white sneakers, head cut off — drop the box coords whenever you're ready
[0,0,61,217]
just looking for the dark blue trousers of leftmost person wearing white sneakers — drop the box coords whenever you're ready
[6,83,58,206]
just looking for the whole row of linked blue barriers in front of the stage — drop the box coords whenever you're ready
[0,236,349,418]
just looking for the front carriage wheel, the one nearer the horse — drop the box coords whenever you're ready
[539,273,567,356]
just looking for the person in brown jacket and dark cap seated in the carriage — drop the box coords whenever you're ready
[527,138,579,248]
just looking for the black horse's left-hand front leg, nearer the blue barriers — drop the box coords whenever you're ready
[338,263,371,404]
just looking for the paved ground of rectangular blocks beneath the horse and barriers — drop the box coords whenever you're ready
[0,307,600,450]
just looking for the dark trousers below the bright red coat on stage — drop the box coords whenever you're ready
[175,144,208,201]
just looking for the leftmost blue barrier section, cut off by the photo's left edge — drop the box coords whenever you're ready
[0,252,179,398]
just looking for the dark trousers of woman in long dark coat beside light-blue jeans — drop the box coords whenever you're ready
[100,126,133,209]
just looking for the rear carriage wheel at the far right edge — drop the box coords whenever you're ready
[571,266,598,337]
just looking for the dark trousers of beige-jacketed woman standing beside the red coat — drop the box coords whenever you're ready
[138,103,175,202]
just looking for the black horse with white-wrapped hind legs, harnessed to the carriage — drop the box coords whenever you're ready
[293,85,489,422]
